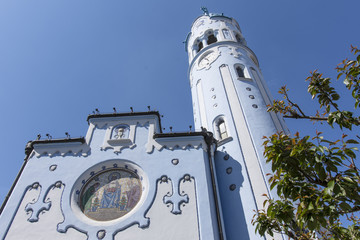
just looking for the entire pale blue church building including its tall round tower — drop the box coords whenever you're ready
[0,9,287,240]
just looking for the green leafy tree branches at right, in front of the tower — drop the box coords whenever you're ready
[253,47,360,240]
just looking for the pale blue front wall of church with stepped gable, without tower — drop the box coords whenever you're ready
[0,112,221,240]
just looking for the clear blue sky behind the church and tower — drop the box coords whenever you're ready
[0,0,360,202]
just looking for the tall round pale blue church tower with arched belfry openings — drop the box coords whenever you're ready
[186,8,287,239]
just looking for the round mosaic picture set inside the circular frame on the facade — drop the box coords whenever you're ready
[79,169,142,221]
